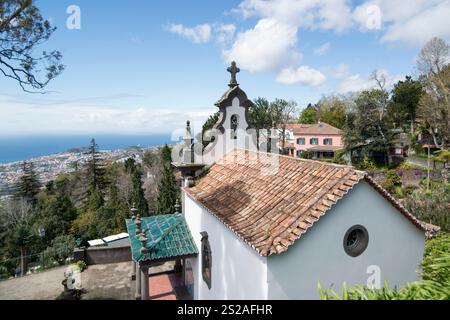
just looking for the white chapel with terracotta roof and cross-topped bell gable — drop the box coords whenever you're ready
[175,62,432,299]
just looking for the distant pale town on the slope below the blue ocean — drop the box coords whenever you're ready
[0,146,158,199]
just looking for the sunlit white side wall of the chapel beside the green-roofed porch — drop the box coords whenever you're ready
[184,194,267,300]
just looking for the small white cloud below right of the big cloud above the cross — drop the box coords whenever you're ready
[276,66,326,87]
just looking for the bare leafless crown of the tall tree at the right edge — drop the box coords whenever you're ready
[417,37,449,77]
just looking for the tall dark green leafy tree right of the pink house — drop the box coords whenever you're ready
[388,76,424,134]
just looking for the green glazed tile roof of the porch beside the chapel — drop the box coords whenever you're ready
[125,213,198,262]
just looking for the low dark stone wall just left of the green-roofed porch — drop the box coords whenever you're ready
[74,246,131,265]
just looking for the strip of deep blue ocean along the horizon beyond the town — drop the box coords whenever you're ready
[0,134,174,163]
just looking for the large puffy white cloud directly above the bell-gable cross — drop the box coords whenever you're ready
[223,19,297,71]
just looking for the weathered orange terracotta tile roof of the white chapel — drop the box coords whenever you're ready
[184,149,425,256]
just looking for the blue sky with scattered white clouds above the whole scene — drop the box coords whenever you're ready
[0,0,450,135]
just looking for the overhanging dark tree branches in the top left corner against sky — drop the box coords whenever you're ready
[0,0,64,92]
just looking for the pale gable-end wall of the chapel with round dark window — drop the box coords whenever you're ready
[267,182,425,299]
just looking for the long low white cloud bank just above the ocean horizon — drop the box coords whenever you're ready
[0,96,211,135]
